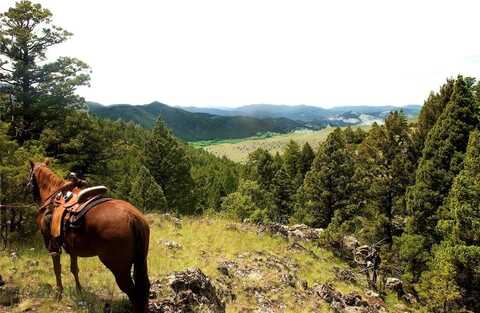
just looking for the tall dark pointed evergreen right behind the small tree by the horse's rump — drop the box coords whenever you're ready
[145,119,196,213]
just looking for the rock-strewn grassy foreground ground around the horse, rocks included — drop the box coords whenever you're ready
[0,216,413,313]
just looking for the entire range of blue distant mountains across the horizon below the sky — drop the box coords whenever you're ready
[87,101,421,141]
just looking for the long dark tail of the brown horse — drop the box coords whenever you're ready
[132,216,150,312]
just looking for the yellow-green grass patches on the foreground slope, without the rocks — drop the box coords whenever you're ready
[0,214,410,313]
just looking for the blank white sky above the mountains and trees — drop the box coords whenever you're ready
[0,0,480,107]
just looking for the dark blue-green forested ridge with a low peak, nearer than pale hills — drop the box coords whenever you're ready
[88,102,308,141]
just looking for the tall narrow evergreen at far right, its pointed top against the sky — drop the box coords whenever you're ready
[404,76,478,279]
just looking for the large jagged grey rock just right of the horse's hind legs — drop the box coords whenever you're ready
[149,268,225,313]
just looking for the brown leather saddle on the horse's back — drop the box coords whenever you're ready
[50,186,111,238]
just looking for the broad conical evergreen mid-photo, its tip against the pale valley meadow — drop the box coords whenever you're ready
[296,128,354,227]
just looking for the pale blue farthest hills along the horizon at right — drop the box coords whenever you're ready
[183,104,421,120]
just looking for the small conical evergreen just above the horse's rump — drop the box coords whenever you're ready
[129,166,167,212]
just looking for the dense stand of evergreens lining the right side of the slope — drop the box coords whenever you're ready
[230,76,480,312]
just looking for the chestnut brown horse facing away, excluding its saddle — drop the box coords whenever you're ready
[29,161,150,313]
